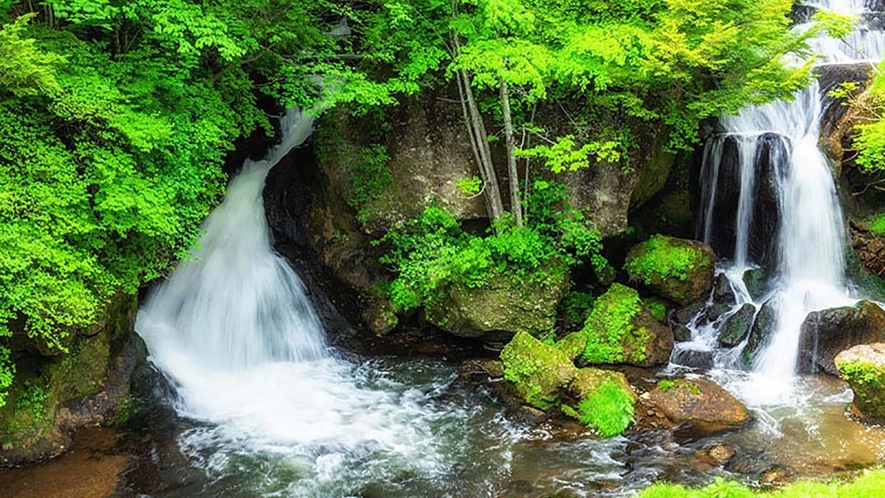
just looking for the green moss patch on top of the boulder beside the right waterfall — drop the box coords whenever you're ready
[624,235,706,285]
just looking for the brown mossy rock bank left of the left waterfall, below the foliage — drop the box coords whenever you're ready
[0,296,147,467]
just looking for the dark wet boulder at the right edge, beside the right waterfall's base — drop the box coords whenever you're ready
[799,301,885,375]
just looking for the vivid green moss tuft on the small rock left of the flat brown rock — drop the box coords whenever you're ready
[578,380,635,437]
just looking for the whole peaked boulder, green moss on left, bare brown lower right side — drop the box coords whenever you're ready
[580,284,673,367]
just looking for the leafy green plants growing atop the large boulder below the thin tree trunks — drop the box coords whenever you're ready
[377,181,602,310]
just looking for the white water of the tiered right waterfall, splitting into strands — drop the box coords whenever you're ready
[696,0,885,406]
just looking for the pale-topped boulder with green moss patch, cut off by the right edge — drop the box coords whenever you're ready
[835,342,885,423]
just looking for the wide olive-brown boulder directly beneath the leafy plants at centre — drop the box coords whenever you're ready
[424,261,569,340]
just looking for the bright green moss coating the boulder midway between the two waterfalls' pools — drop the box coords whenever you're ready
[581,284,651,364]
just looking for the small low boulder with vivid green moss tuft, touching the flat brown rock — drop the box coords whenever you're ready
[569,368,637,437]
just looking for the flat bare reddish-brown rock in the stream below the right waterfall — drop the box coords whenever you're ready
[648,379,750,434]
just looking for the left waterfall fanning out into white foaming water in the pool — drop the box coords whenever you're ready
[136,113,524,496]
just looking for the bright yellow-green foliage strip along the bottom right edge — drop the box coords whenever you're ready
[639,469,885,498]
